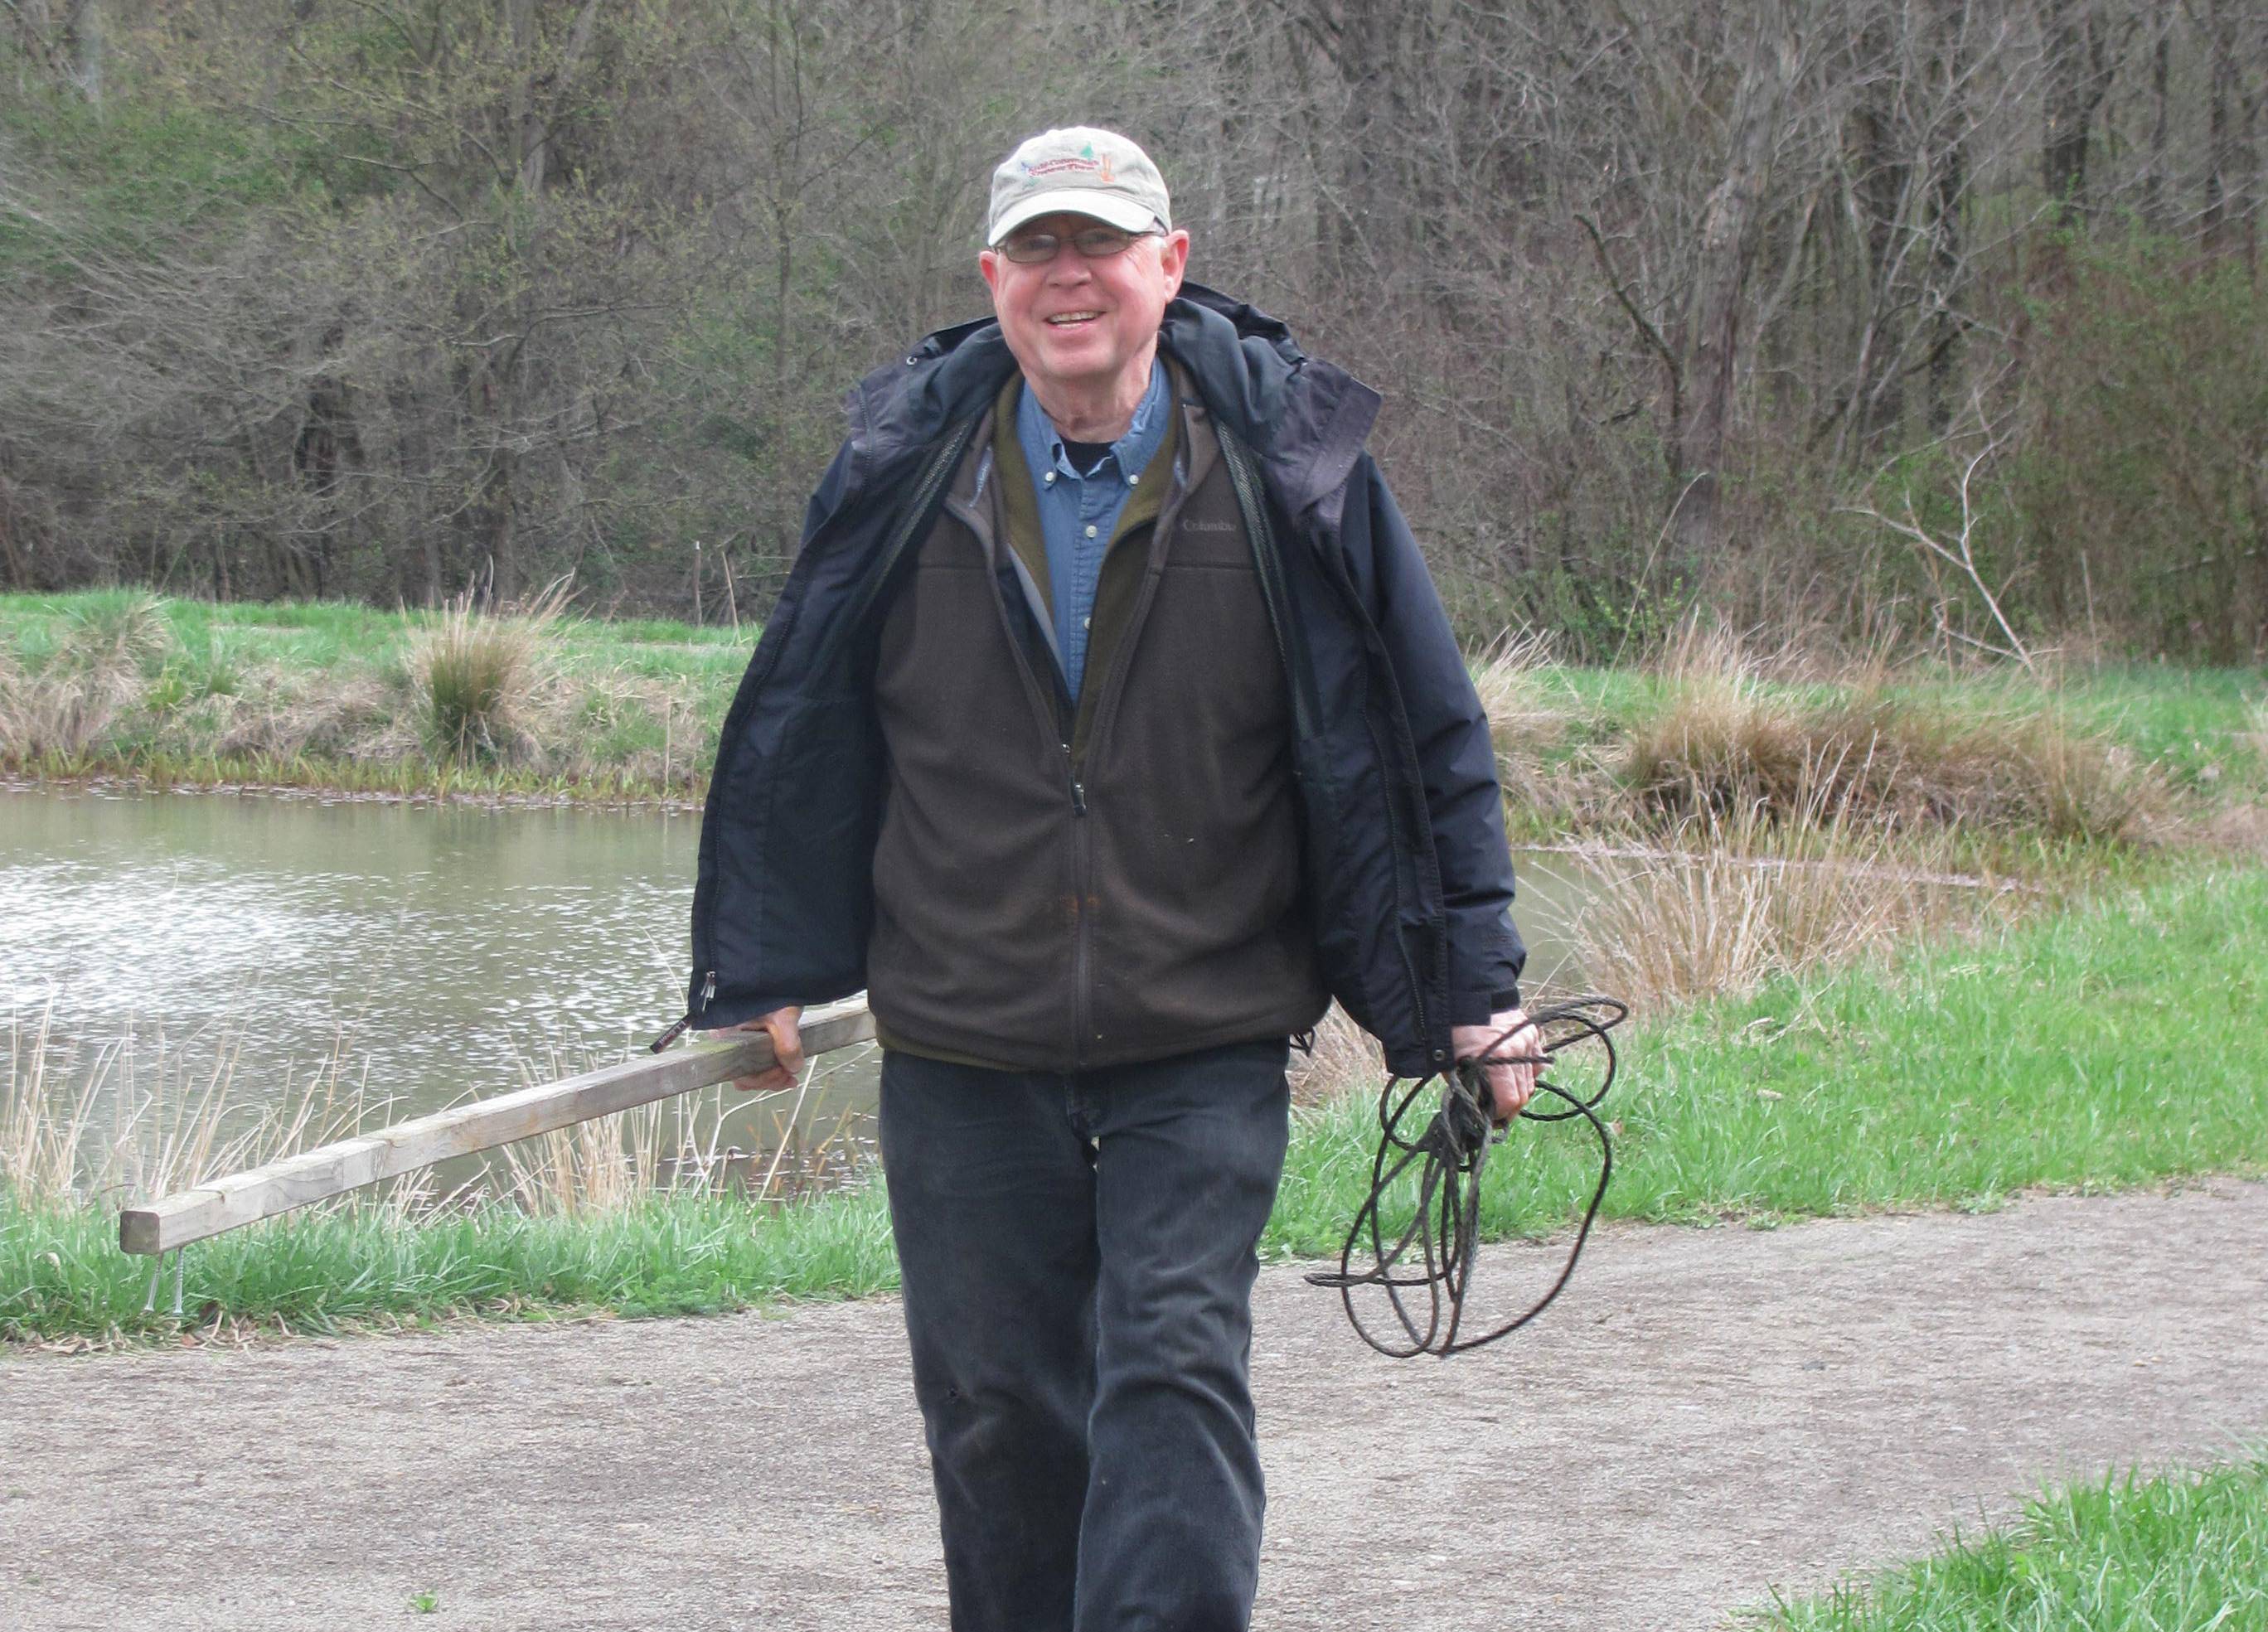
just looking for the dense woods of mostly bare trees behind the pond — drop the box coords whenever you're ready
[0,0,2268,662]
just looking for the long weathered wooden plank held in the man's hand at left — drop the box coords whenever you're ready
[118,997,873,1253]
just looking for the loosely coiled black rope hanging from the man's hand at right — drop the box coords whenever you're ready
[1309,997,1631,1360]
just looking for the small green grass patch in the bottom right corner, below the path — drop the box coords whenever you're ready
[1751,1453,2268,1632]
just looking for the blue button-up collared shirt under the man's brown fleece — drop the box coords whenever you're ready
[1016,358,1166,700]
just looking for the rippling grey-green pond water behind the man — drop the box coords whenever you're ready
[0,787,1581,1205]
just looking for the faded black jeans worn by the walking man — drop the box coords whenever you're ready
[882,1040,1288,1632]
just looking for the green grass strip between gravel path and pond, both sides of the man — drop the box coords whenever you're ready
[0,864,2268,1337]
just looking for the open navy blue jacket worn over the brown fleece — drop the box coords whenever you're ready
[687,283,1526,1077]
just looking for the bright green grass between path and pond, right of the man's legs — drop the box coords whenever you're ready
[1270,864,2268,1256]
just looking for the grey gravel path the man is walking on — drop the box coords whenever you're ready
[13,1184,2268,1632]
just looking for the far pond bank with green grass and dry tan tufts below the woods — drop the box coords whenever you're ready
[0,589,2268,841]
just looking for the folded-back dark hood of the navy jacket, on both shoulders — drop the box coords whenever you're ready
[846,283,1379,515]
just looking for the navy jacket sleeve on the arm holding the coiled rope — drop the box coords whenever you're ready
[1340,453,1526,1024]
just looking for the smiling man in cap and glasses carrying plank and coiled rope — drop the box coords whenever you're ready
[690,129,1531,1632]
